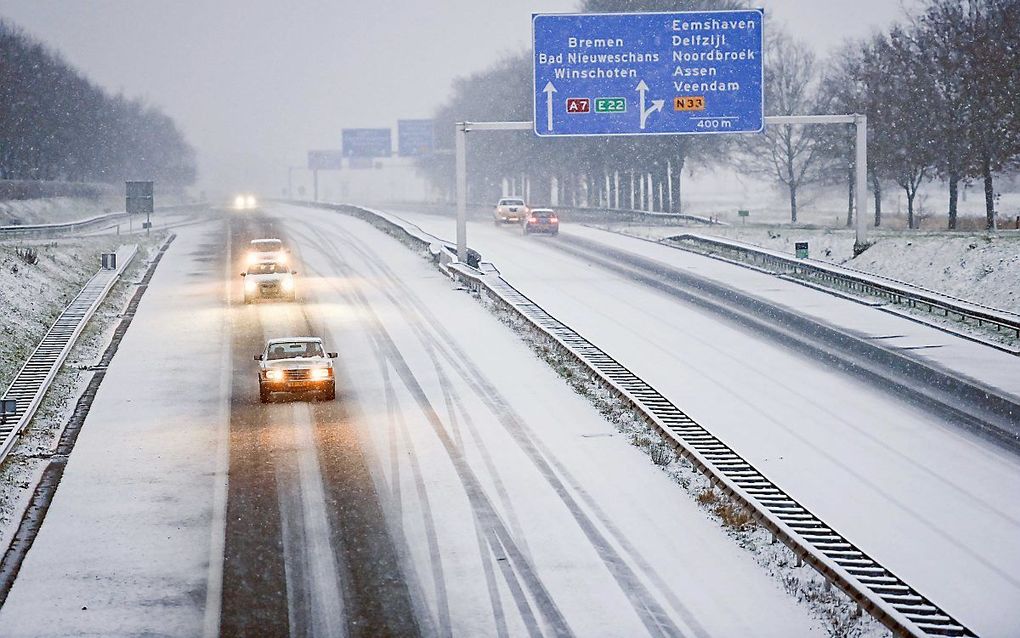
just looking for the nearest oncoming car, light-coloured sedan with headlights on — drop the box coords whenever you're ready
[255,337,337,403]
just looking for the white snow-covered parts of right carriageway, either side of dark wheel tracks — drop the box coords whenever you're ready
[379,206,1020,636]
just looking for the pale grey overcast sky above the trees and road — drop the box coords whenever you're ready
[0,0,916,193]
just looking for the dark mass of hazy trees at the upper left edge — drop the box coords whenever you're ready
[0,21,196,186]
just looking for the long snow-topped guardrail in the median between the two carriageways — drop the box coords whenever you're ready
[301,199,974,638]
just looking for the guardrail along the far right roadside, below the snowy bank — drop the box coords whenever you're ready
[667,233,1020,342]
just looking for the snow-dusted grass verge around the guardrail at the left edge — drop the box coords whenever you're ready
[0,234,164,548]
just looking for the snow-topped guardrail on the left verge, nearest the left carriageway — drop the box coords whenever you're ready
[0,246,138,461]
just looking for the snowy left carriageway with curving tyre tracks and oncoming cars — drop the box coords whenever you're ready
[0,207,824,636]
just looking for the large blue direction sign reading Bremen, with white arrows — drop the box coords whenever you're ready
[531,9,765,136]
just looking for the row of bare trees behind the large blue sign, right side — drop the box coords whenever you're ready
[423,0,1020,229]
